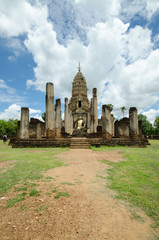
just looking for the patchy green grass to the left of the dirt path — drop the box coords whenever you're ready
[0,141,68,197]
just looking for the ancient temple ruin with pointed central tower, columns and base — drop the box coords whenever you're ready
[10,66,147,148]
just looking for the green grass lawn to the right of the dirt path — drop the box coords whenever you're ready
[93,140,159,227]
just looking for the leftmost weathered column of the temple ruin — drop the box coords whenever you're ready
[20,108,29,139]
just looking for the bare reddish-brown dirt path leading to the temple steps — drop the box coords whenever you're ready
[0,150,157,240]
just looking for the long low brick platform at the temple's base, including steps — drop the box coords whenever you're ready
[9,137,148,149]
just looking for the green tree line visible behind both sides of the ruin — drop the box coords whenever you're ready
[0,115,159,136]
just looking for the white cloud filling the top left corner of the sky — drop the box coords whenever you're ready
[0,0,47,37]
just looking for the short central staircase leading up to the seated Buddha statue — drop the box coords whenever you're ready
[70,137,90,149]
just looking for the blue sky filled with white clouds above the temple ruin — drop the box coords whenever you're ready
[0,0,159,123]
